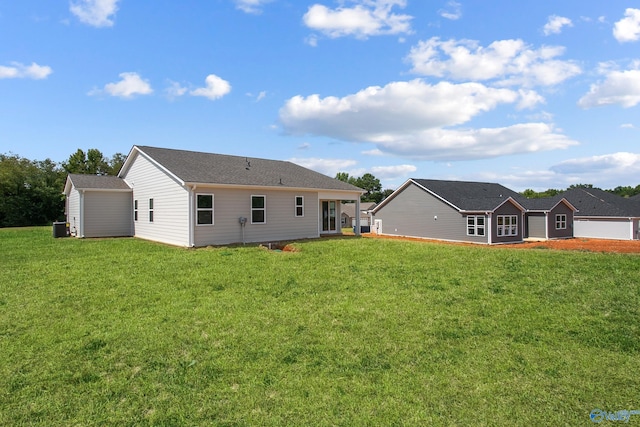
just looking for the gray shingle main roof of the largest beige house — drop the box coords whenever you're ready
[137,146,362,192]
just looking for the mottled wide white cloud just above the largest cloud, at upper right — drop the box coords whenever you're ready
[407,37,581,86]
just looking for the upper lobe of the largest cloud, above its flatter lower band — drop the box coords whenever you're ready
[280,79,518,137]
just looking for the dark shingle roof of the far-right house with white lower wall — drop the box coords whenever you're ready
[561,188,640,218]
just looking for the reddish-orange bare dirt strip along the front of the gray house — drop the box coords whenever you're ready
[363,233,640,253]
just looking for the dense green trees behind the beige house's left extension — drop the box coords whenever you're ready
[0,148,126,227]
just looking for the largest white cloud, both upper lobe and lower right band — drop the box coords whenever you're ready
[280,79,576,160]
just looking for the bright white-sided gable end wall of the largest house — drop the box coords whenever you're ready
[122,154,190,246]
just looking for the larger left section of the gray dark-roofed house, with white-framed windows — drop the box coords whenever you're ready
[373,179,526,244]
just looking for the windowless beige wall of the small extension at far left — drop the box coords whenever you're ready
[83,191,133,237]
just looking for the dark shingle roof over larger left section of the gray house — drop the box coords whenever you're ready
[412,179,522,211]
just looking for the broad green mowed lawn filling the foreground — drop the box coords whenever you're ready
[0,228,640,426]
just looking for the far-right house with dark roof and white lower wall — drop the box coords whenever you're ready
[561,188,640,240]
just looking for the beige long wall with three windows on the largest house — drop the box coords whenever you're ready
[193,187,319,246]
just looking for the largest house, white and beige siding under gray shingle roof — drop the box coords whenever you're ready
[65,146,364,247]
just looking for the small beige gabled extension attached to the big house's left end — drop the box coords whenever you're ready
[64,174,133,241]
